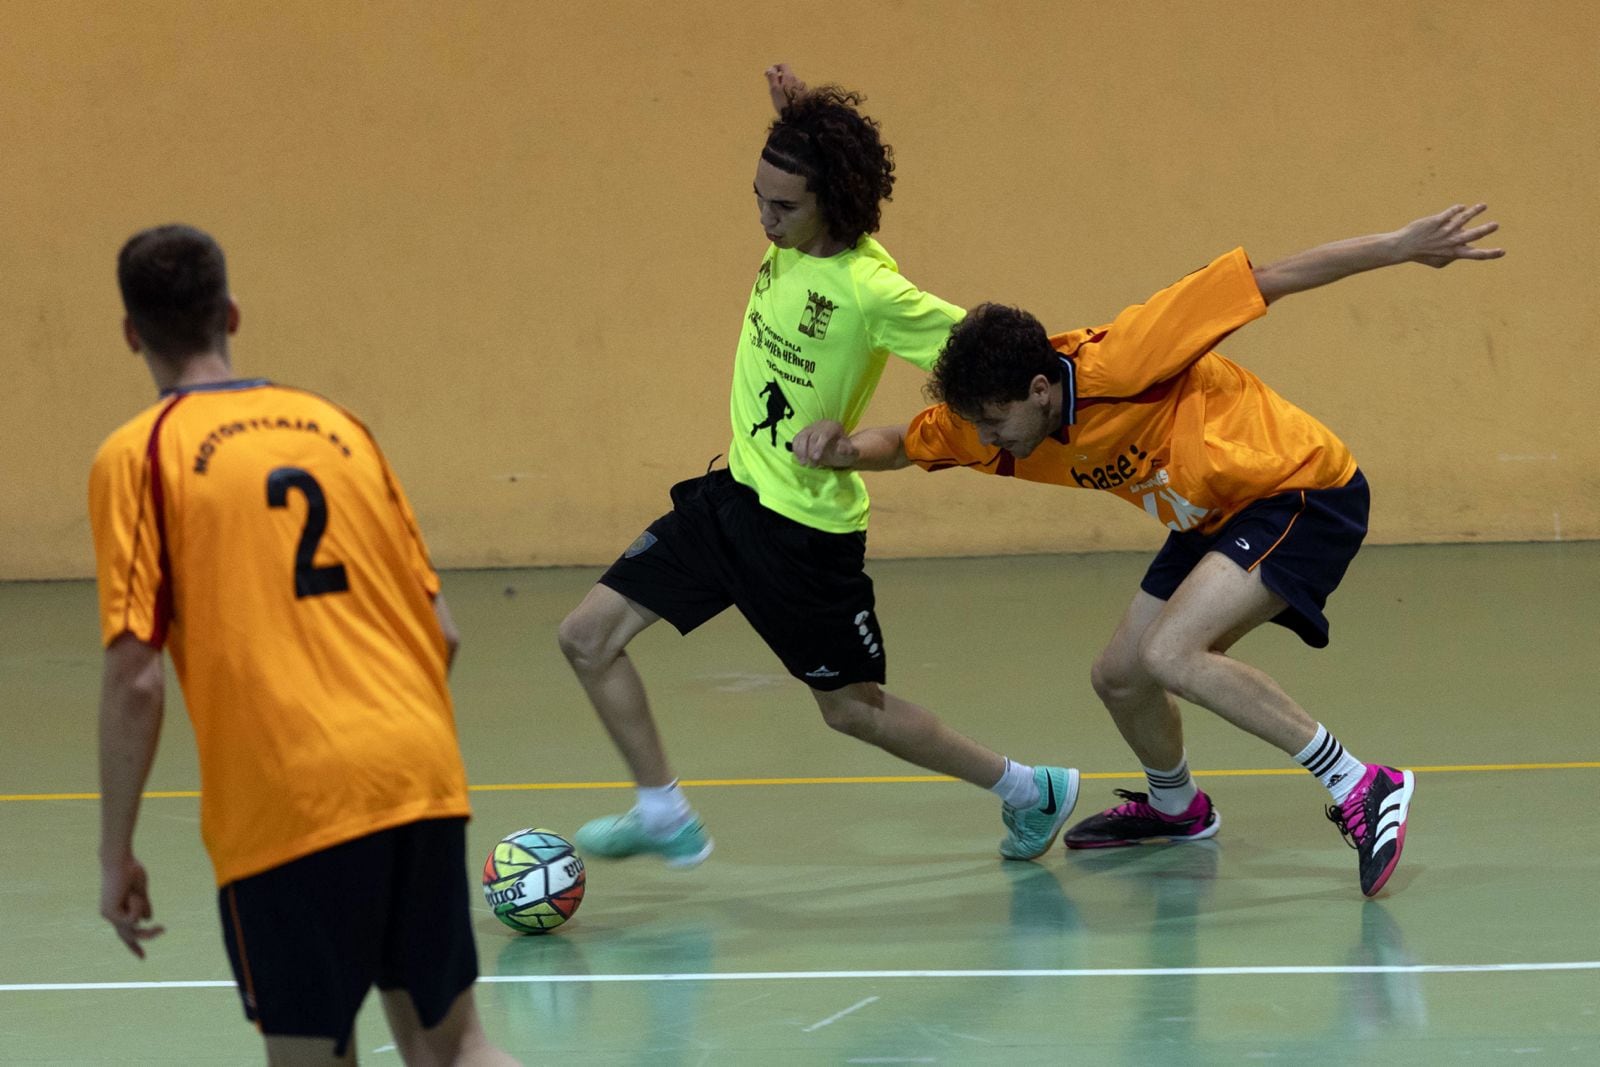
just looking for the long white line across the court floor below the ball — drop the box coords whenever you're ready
[0,960,1600,993]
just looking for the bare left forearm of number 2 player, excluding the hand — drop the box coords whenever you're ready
[99,638,165,862]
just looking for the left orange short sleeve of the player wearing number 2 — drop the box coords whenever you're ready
[90,434,166,648]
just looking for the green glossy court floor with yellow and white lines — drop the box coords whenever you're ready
[0,544,1600,1065]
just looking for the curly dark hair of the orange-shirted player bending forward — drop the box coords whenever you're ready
[923,304,1061,419]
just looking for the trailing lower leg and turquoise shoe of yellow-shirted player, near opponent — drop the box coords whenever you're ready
[811,681,1078,859]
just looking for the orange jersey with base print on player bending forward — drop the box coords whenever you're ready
[906,248,1355,533]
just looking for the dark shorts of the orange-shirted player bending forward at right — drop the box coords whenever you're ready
[1139,470,1370,648]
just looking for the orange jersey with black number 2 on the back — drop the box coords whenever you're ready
[90,381,469,885]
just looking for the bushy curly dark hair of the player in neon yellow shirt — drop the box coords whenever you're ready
[762,85,894,245]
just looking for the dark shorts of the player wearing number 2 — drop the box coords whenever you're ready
[218,819,478,1056]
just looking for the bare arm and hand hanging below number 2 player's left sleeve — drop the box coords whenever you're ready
[99,633,165,960]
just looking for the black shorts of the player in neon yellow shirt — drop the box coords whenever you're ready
[600,470,885,689]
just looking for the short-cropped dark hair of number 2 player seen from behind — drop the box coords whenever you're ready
[117,226,227,360]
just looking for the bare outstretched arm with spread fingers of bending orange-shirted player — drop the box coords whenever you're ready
[1254,203,1506,304]
